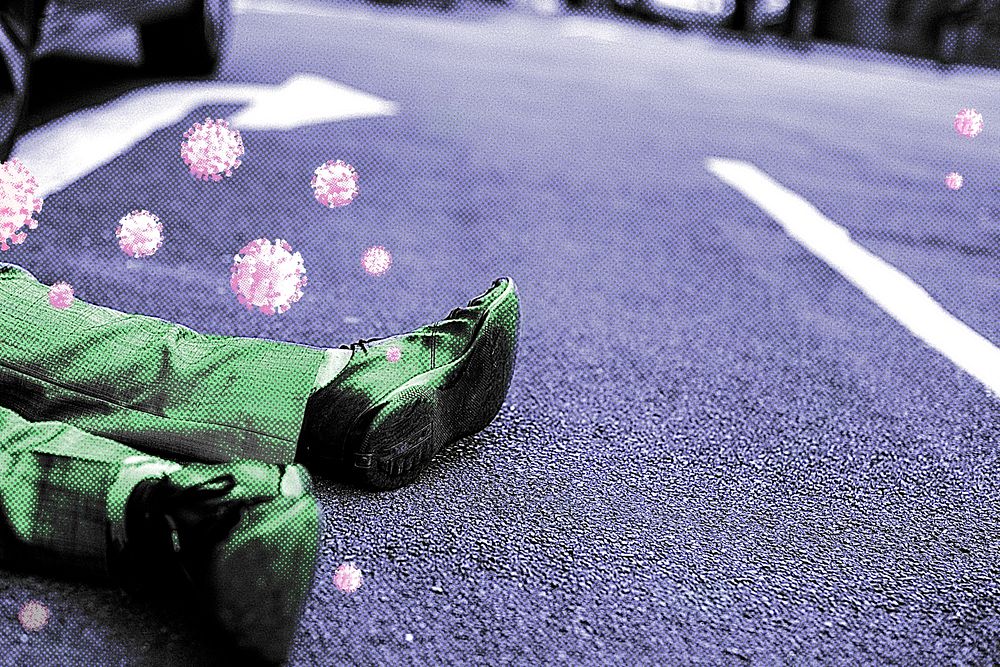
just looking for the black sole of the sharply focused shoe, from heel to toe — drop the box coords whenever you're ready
[348,278,520,490]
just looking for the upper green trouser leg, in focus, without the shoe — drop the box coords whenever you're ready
[0,264,324,465]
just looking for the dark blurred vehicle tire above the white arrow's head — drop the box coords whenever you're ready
[139,0,232,76]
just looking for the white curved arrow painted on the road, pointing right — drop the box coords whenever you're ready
[13,74,398,197]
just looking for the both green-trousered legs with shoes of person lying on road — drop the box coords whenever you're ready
[0,265,519,662]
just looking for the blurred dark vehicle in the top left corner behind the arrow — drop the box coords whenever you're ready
[0,0,230,160]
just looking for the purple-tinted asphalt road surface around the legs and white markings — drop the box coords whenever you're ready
[0,3,1000,666]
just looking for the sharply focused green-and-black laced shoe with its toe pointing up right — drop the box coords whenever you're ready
[300,278,520,489]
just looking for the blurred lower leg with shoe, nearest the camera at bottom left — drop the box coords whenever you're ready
[0,408,322,661]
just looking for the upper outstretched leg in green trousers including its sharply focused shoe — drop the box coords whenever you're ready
[0,265,520,488]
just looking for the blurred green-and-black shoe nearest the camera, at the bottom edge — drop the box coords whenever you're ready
[115,461,322,664]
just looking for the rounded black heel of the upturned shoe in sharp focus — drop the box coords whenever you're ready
[353,385,443,490]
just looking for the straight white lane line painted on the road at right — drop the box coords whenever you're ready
[705,158,1000,397]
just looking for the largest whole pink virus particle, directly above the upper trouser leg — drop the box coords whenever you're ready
[229,239,306,315]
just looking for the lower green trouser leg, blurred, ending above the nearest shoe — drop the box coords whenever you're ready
[0,407,180,578]
